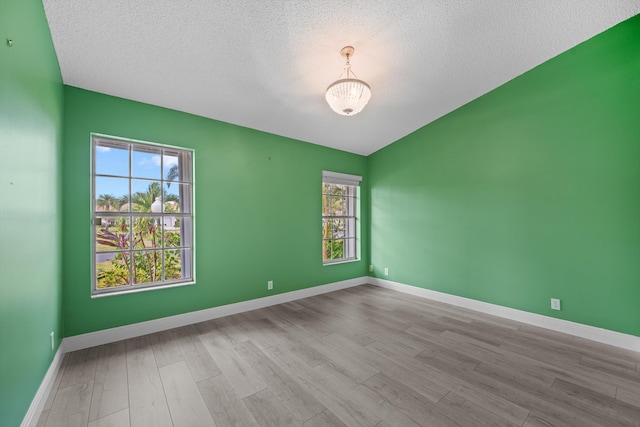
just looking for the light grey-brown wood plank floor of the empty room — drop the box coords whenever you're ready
[38,285,640,427]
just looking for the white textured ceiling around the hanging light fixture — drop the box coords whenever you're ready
[43,0,640,155]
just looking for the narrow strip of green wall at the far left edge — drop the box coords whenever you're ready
[0,0,63,426]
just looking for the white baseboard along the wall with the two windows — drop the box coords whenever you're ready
[62,276,369,352]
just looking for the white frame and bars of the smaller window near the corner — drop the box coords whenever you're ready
[322,171,362,265]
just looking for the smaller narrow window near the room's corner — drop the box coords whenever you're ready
[322,171,362,264]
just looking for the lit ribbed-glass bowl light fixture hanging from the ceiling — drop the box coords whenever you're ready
[325,46,371,116]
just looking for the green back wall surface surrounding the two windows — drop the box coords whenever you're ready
[63,86,368,336]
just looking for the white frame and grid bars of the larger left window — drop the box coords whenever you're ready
[91,133,195,298]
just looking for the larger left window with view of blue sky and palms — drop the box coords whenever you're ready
[91,135,194,295]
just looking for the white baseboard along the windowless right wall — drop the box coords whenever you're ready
[369,277,640,352]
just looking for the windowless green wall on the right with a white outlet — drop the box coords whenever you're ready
[369,16,640,335]
